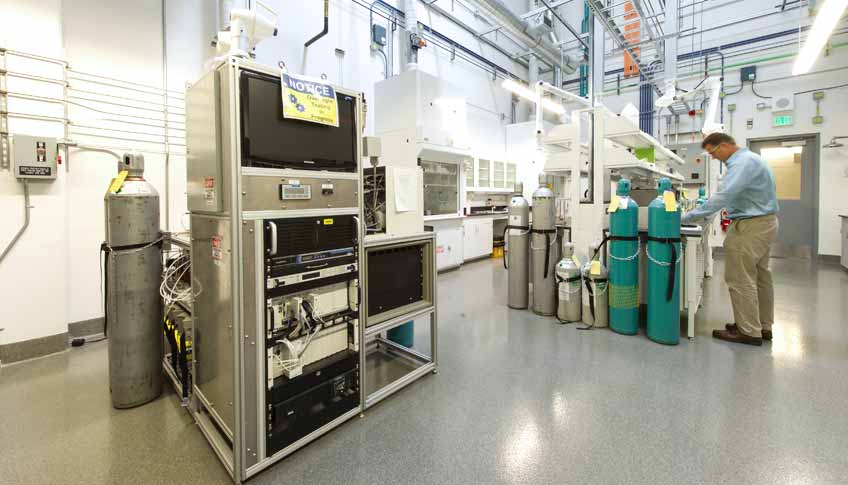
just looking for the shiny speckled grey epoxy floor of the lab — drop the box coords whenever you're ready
[0,255,848,484]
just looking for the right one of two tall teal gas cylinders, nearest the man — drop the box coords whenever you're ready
[646,178,681,345]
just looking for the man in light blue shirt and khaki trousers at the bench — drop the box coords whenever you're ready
[682,133,779,346]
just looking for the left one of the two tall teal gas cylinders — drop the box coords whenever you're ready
[609,179,639,335]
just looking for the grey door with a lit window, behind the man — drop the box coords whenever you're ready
[748,135,819,259]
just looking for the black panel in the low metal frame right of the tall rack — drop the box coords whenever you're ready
[367,246,424,315]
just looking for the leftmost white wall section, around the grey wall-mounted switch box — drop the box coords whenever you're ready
[0,0,67,344]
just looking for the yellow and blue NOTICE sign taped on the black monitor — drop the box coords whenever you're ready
[282,73,339,127]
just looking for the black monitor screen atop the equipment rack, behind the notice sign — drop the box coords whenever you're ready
[240,71,357,172]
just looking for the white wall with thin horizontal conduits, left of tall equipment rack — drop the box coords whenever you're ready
[0,0,215,344]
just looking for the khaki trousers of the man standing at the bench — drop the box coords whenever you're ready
[724,215,779,337]
